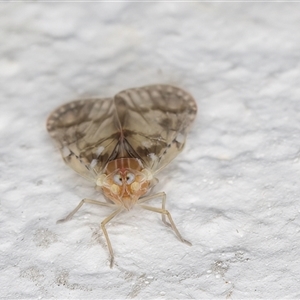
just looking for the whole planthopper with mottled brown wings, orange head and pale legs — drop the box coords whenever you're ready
[47,85,197,267]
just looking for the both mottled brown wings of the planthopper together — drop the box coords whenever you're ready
[47,85,197,180]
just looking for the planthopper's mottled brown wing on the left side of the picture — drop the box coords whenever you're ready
[47,98,120,181]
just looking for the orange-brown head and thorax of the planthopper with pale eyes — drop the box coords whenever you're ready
[97,158,151,209]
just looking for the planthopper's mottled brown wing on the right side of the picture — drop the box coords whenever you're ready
[114,85,197,174]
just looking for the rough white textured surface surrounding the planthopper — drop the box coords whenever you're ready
[0,3,300,299]
